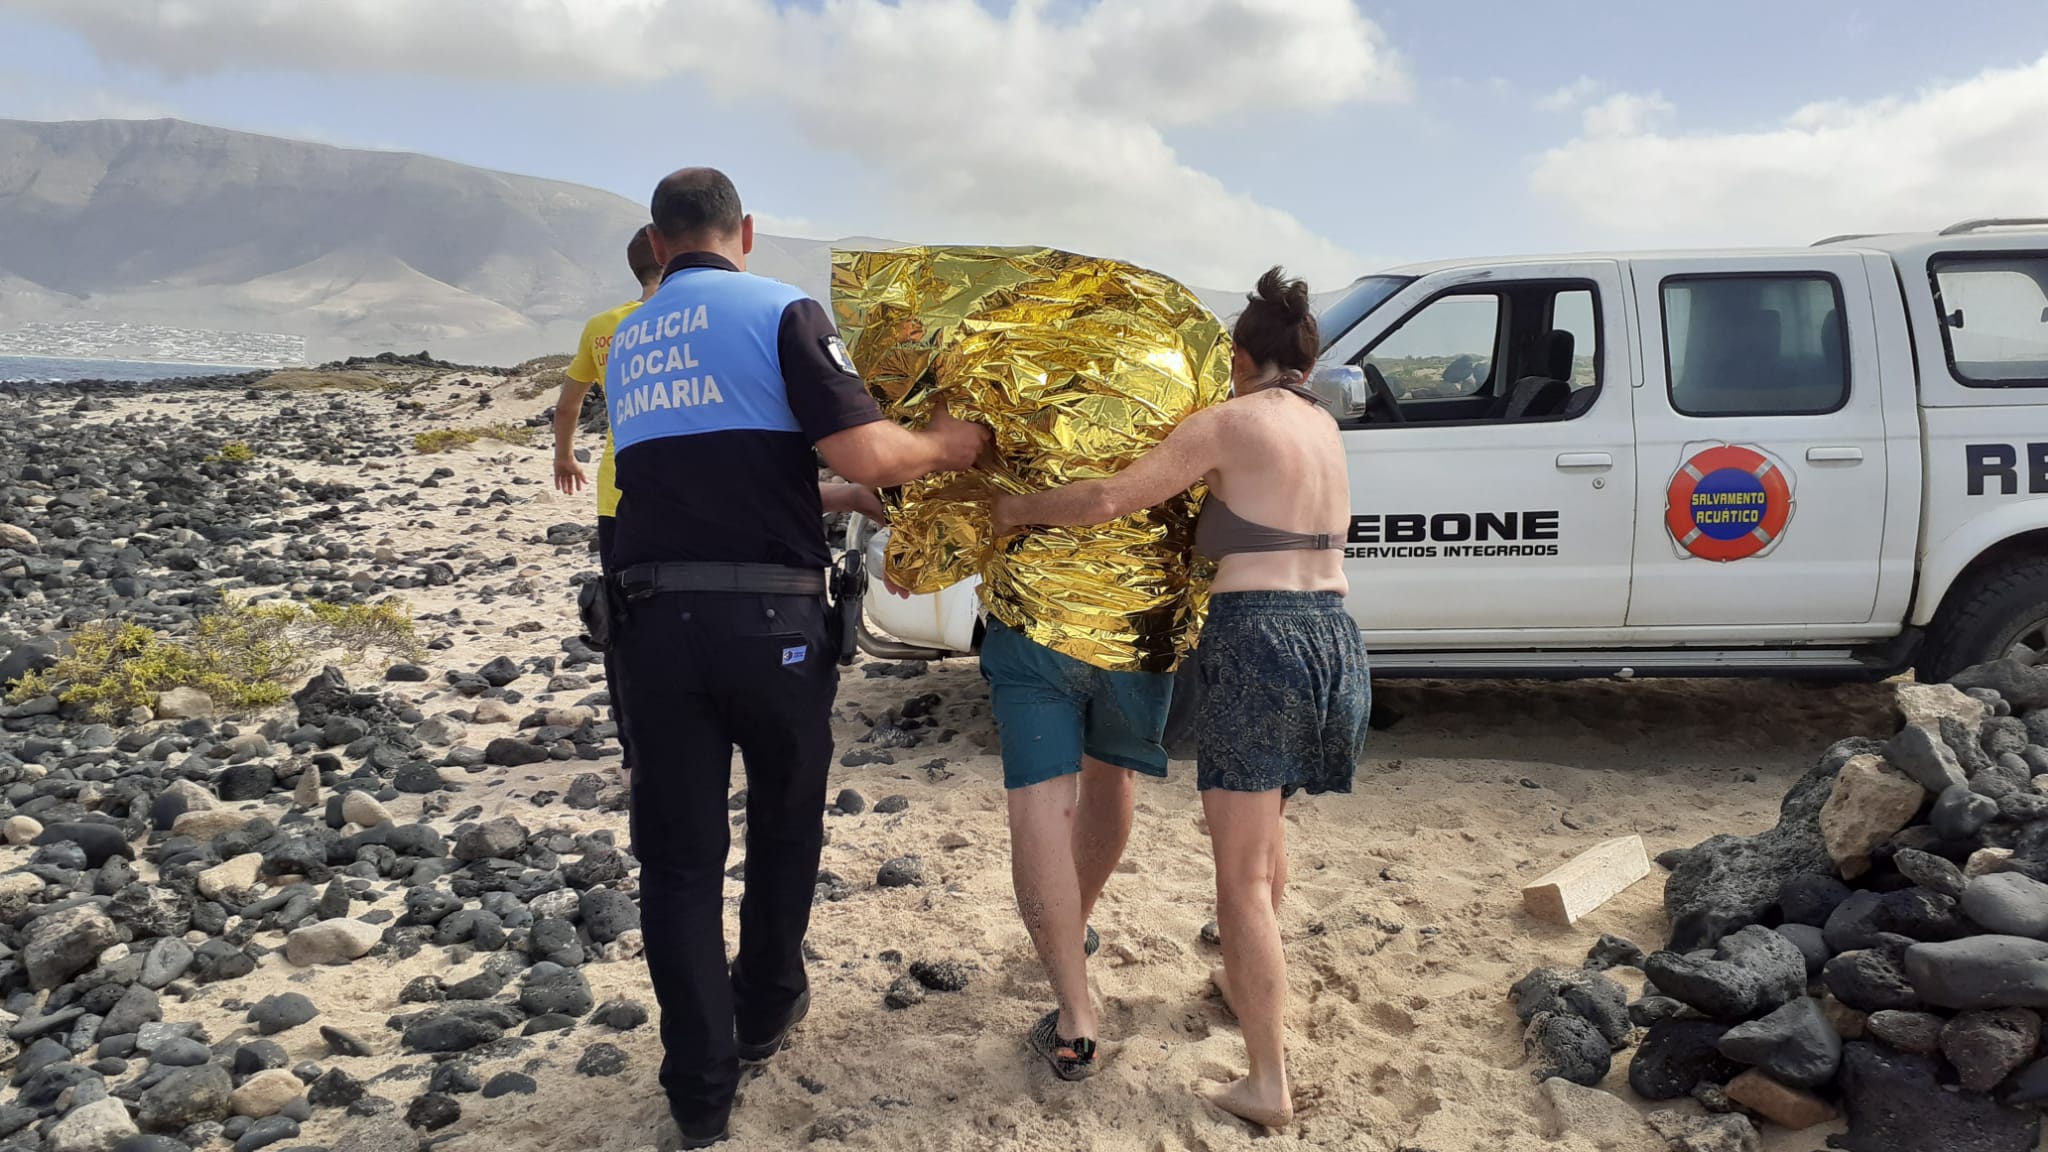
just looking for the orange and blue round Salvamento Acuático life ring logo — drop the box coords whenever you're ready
[1665,445,1792,564]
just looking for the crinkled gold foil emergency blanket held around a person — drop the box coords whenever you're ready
[831,248,1231,672]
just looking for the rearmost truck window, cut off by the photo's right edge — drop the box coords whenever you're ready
[1927,252,2048,387]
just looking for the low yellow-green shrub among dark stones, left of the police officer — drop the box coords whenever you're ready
[8,601,424,719]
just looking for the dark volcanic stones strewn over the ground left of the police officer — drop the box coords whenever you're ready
[0,368,991,1152]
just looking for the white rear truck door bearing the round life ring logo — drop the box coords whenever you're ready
[1628,252,1886,627]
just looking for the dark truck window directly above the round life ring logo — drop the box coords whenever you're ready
[1663,273,1849,416]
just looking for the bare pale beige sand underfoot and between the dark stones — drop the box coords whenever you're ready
[39,381,1888,1152]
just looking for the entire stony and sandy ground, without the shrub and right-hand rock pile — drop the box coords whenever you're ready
[0,357,1933,1152]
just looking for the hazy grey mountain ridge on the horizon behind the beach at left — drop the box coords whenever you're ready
[0,119,1243,363]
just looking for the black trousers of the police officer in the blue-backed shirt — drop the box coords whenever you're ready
[614,592,840,1123]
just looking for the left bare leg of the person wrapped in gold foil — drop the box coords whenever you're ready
[1010,775,1114,1039]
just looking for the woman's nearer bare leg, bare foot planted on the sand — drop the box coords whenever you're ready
[1202,789,1294,1127]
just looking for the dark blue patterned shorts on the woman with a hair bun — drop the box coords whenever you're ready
[1194,592,1372,795]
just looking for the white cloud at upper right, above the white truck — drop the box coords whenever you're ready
[1532,57,2048,244]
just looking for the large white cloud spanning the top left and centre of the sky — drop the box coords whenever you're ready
[0,0,1409,285]
